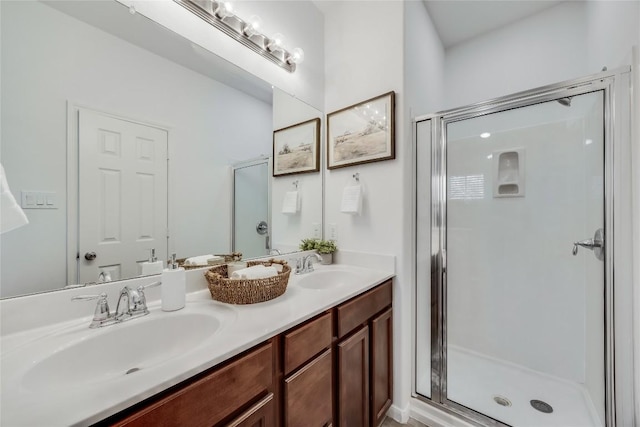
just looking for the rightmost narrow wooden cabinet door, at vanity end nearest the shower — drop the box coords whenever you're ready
[371,309,393,426]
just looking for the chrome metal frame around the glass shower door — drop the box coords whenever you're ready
[413,67,630,427]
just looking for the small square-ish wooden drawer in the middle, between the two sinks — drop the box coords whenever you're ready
[284,312,332,375]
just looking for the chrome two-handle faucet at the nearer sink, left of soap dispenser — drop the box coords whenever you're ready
[71,282,162,329]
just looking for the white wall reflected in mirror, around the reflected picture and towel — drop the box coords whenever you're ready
[269,89,325,253]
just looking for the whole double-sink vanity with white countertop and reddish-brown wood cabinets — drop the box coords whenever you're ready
[1,265,393,426]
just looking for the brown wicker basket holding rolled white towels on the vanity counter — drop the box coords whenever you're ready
[204,259,291,304]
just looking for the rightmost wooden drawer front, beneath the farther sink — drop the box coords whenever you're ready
[336,280,391,338]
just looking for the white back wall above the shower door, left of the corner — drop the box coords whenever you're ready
[445,2,588,108]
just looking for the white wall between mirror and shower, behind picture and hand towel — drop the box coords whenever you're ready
[325,1,412,416]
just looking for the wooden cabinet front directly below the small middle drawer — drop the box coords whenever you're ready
[284,349,333,427]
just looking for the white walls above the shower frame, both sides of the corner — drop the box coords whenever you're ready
[445,0,640,108]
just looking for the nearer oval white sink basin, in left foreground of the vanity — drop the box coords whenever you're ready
[22,307,232,391]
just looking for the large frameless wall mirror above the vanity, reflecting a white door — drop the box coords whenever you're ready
[0,0,323,297]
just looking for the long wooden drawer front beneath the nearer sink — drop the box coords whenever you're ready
[114,341,273,427]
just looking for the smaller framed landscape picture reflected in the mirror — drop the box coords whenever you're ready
[273,119,320,176]
